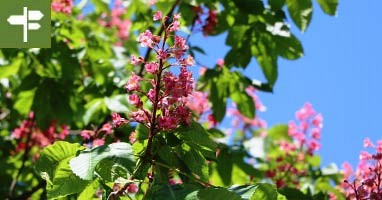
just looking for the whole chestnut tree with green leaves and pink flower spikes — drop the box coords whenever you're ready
[0,0,372,200]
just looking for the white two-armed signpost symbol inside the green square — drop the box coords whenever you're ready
[7,7,44,42]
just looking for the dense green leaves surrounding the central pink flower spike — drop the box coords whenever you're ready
[0,0,344,200]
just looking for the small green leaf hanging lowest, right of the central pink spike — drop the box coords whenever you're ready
[231,92,256,119]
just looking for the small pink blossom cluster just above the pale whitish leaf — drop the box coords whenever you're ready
[81,123,113,147]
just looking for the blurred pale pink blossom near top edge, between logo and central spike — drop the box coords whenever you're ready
[98,0,132,40]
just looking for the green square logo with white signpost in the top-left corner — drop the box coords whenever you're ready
[0,0,51,48]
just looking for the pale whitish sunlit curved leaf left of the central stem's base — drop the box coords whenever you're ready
[69,142,135,180]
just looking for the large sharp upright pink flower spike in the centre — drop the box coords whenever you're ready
[113,11,194,131]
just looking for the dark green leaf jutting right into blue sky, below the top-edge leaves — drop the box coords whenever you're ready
[275,35,304,60]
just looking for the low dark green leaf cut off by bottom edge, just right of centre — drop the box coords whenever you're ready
[185,188,241,200]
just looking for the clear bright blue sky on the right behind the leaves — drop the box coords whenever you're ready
[192,0,382,166]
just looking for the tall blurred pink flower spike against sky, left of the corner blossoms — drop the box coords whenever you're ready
[265,103,323,188]
